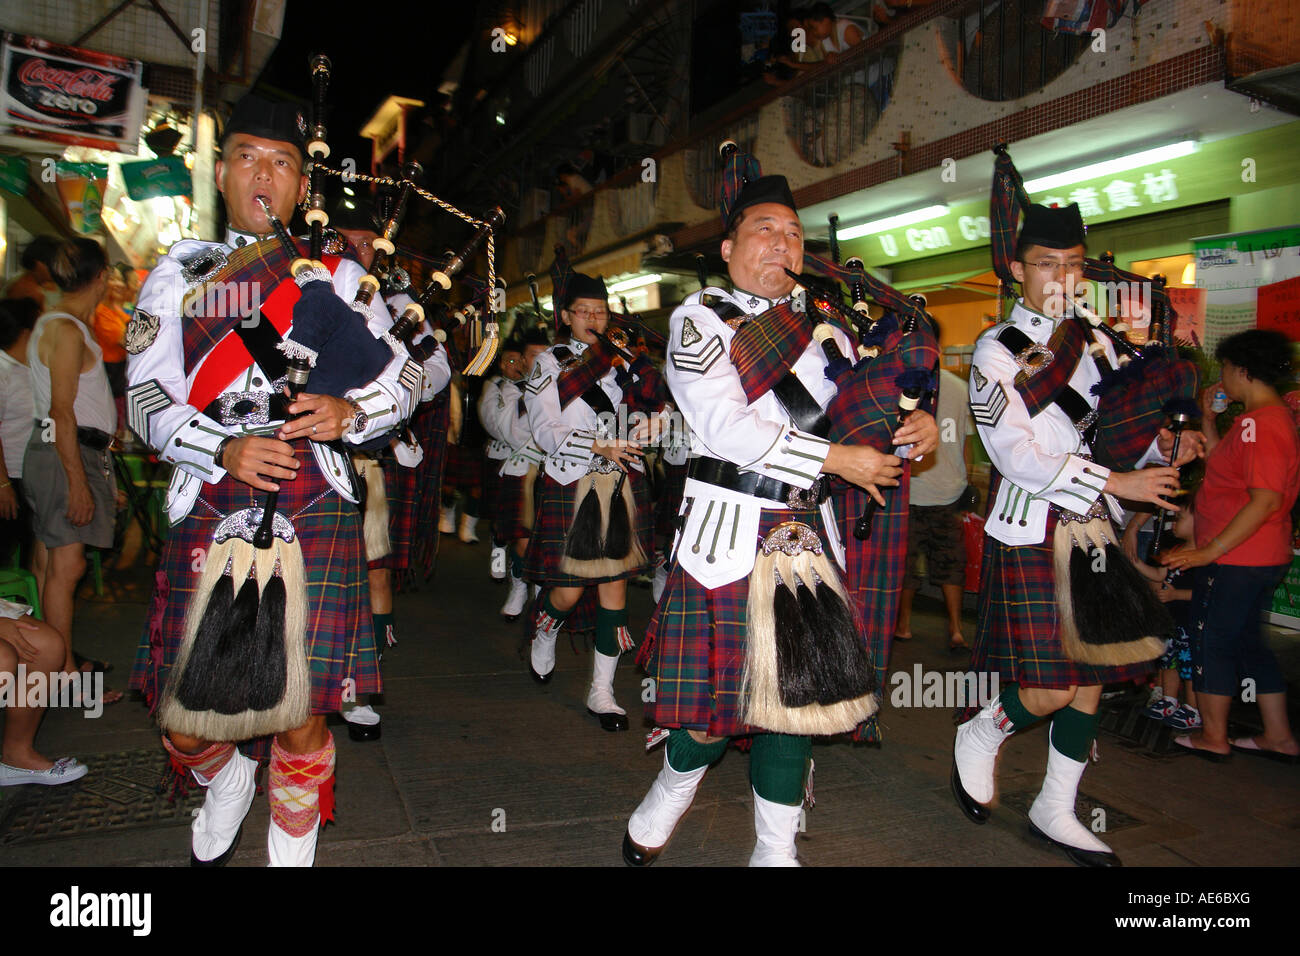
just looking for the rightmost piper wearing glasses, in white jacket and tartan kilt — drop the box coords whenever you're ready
[952,204,1203,866]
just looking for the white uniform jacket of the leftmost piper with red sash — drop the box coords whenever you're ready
[126,232,424,524]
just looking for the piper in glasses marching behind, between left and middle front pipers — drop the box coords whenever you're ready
[524,255,664,731]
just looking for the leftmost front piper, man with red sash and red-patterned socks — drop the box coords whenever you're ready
[125,95,421,866]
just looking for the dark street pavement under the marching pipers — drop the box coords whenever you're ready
[0,536,1300,868]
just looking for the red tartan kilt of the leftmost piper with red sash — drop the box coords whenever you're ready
[130,457,382,714]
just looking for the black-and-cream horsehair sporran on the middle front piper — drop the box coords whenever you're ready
[742,522,876,736]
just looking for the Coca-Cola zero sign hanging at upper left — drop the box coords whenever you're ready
[0,34,144,152]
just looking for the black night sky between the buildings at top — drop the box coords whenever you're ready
[257,0,475,170]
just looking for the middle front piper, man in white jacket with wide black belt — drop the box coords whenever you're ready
[623,152,937,866]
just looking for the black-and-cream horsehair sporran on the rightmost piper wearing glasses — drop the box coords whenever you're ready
[1052,498,1174,666]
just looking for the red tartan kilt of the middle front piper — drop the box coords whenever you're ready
[637,510,861,736]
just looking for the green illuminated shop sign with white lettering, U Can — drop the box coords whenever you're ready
[841,122,1300,267]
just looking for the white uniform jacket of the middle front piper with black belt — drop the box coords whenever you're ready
[664,287,853,588]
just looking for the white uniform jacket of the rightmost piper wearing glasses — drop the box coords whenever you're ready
[970,300,1165,545]
